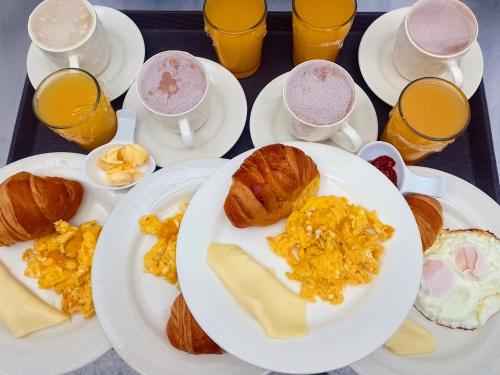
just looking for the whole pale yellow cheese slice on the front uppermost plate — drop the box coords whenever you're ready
[207,243,308,339]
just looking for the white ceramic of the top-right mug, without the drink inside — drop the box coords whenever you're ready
[393,0,478,88]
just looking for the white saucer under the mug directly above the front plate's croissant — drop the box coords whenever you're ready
[250,73,378,151]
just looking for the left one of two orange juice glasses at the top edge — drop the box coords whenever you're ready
[203,0,267,78]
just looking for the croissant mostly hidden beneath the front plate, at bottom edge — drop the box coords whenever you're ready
[166,294,223,354]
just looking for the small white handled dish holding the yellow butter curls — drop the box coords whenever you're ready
[85,109,156,190]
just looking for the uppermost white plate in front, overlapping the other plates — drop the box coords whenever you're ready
[177,142,422,373]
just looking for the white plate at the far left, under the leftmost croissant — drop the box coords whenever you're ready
[0,152,119,375]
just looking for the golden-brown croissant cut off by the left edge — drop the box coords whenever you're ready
[0,172,83,246]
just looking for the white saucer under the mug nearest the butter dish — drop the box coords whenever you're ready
[123,57,247,167]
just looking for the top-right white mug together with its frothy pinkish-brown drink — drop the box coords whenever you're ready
[393,0,478,87]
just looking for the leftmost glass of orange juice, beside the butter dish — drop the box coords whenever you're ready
[33,68,116,151]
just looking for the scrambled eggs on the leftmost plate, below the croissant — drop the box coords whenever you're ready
[23,220,102,318]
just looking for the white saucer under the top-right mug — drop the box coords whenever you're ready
[358,8,484,106]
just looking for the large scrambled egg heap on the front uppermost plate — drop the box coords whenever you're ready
[268,196,394,304]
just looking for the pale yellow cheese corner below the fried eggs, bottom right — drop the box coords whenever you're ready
[384,319,436,355]
